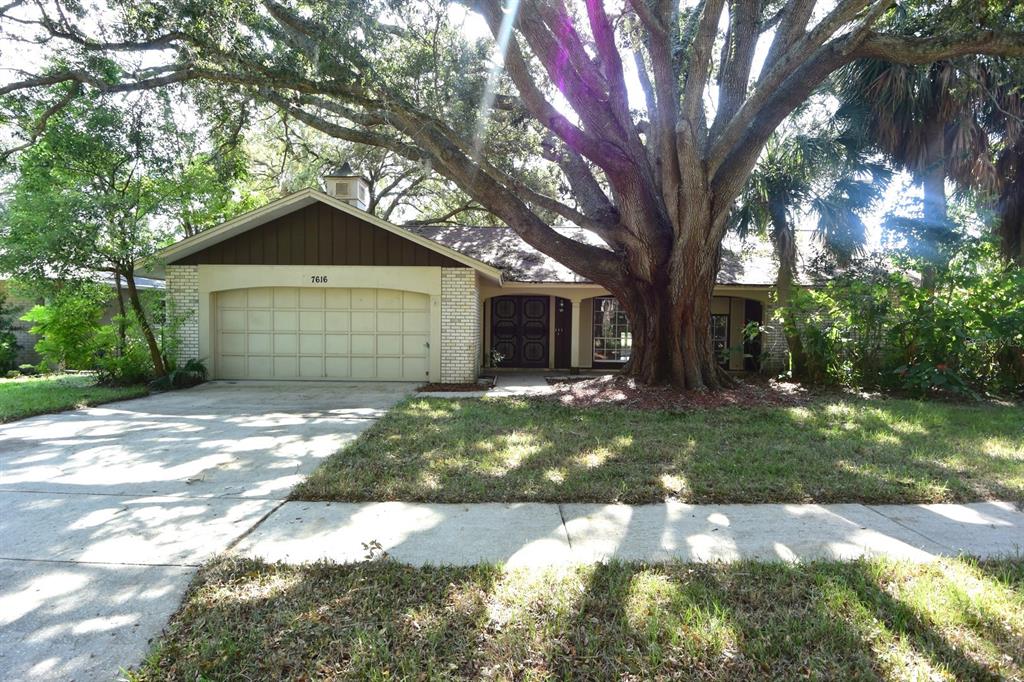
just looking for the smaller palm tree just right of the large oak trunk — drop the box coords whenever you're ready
[731,127,891,377]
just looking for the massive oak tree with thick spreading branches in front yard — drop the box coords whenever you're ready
[0,0,1024,388]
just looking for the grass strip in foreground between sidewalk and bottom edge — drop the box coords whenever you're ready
[129,559,1024,681]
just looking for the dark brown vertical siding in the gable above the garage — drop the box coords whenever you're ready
[171,202,466,267]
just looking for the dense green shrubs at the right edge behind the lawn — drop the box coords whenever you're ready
[784,239,1024,395]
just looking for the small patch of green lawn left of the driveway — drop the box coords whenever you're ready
[0,374,150,423]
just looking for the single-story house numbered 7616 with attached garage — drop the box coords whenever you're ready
[145,169,784,383]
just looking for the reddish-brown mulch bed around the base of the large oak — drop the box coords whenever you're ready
[541,375,813,411]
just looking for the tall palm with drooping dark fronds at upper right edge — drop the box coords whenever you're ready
[835,56,1024,266]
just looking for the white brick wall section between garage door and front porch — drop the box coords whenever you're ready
[440,267,482,383]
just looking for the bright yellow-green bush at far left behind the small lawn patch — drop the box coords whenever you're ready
[22,284,111,370]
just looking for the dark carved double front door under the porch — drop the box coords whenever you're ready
[490,296,549,368]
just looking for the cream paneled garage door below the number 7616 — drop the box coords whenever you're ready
[216,287,430,381]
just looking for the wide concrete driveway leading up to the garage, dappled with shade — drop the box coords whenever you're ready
[0,382,413,680]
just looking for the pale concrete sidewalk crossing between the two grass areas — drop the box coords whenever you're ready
[236,502,1024,566]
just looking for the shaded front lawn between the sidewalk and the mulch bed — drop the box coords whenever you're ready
[293,397,1024,503]
